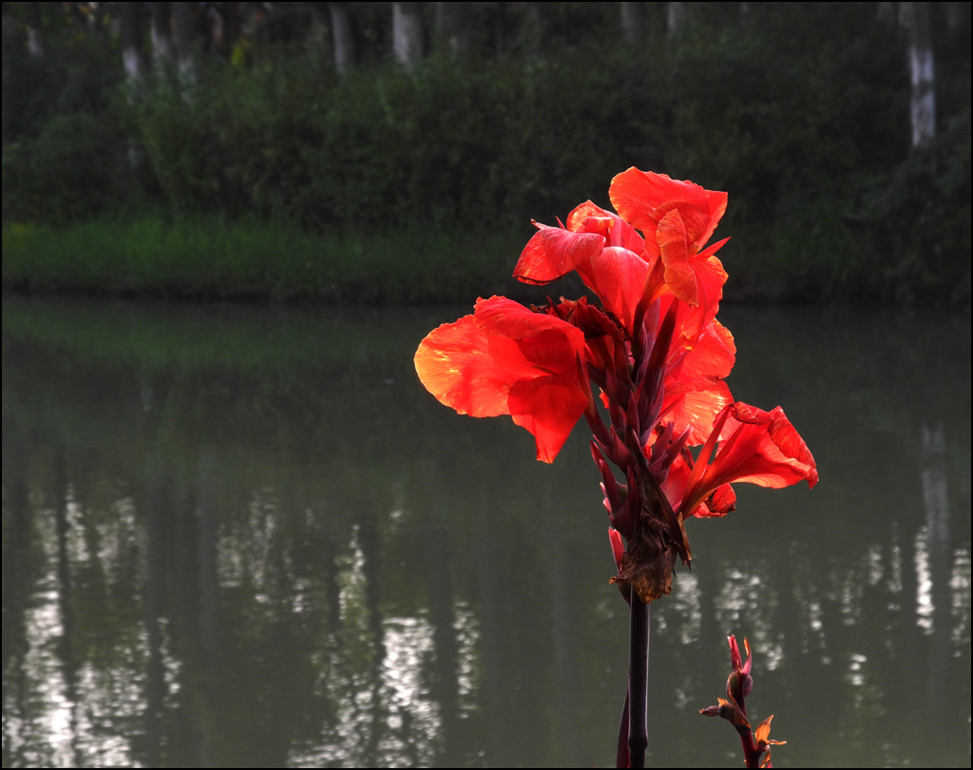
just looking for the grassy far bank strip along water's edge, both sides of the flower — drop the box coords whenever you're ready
[2,212,970,307]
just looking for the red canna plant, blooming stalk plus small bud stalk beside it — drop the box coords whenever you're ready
[415,168,818,766]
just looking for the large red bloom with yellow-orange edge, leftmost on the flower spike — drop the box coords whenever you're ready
[415,297,588,462]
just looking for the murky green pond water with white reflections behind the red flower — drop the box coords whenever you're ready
[2,297,971,767]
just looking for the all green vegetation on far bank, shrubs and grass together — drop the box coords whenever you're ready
[3,3,971,303]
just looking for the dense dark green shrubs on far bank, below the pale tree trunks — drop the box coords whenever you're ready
[3,4,970,300]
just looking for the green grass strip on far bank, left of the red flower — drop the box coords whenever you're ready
[3,215,529,302]
